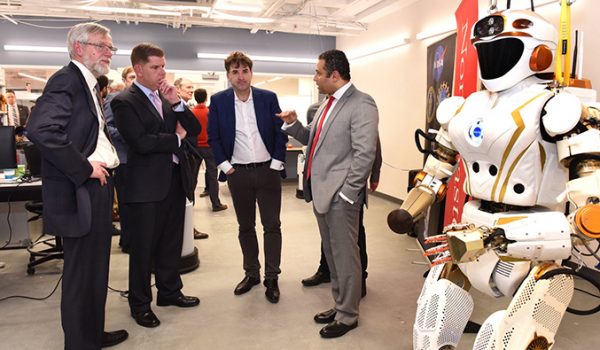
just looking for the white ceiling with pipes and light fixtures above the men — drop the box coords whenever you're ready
[0,0,418,36]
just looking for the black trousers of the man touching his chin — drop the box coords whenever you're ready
[129,166,185,313]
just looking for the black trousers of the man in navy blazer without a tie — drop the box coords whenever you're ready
[227,164,281,279]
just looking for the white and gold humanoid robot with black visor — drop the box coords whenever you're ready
[388,3,600,350]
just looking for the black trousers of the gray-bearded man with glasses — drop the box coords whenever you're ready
[60,177,114,350]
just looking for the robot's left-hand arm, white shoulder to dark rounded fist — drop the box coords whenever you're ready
[388,97,464,233]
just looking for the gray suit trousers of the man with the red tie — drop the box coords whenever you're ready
[313,195,362,325]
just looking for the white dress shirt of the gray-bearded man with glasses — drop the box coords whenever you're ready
[71,60,119,169]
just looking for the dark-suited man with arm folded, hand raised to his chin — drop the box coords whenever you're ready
[111,43,200,327]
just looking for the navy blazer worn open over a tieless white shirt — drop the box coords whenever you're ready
[208,87,288,181]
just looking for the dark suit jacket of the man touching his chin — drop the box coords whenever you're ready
[110,84,200,203]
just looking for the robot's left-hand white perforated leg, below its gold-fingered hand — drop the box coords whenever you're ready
[413,265,473,350]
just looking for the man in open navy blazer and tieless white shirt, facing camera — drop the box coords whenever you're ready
[208,51,287,303]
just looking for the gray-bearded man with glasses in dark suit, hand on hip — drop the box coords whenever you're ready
[27,23,127,350]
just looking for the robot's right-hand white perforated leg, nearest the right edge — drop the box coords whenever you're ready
[473,264,573,350]
